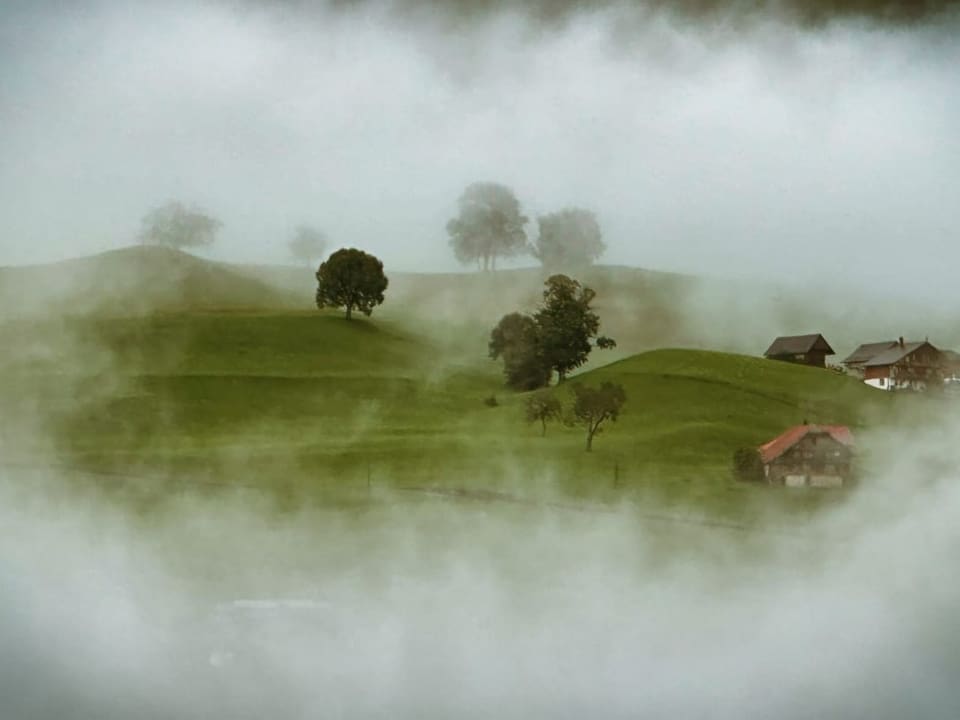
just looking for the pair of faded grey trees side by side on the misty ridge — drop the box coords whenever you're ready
[447,182,606,270]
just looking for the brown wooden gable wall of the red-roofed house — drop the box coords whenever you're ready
[764,433,852,487]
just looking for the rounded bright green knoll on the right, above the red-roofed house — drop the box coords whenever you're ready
[577,350,896,473]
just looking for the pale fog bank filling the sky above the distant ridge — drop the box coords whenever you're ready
[0,2,960,300]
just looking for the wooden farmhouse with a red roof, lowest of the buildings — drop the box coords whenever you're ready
[759,425,853,487]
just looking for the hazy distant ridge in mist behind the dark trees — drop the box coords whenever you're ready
[0,246,960,362]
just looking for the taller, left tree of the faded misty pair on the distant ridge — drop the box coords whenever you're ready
[447,182,527,270]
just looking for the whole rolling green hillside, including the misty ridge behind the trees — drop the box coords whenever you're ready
[0,247,936,516]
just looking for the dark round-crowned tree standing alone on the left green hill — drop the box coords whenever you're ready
[317,248,388,320]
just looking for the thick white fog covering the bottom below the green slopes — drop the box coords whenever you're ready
[0,410,960,719]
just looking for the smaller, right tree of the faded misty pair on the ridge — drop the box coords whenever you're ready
[531,208,607,269]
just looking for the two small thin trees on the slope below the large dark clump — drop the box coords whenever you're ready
[526,382,627,452]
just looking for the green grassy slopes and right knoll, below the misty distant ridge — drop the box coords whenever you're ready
[0,312,916,517]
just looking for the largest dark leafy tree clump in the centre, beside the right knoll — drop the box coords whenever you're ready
[489,275,616,390]
